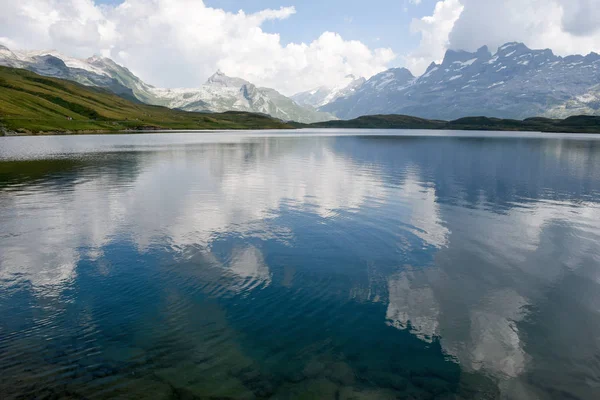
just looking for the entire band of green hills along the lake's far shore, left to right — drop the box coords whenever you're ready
[0,66,600,136]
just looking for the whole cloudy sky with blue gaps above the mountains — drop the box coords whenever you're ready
[0,0,600,95]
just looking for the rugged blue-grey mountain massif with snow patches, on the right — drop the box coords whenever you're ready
[319,43,600,119]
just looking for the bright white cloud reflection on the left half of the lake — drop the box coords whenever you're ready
[0,133,390,294]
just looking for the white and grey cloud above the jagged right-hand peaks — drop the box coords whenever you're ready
[405,0,600,74]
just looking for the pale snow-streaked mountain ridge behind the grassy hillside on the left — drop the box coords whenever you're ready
[0,46,335,123]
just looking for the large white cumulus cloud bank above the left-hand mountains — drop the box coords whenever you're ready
[0,0,395,94]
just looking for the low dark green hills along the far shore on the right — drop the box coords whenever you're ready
[304,115,600,133]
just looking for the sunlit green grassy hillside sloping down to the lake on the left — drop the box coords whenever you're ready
[0,67,291,133]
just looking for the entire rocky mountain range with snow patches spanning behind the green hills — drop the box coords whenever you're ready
[0,43,600,123]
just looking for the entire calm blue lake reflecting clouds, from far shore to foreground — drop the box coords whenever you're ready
[0,131,600,399]
